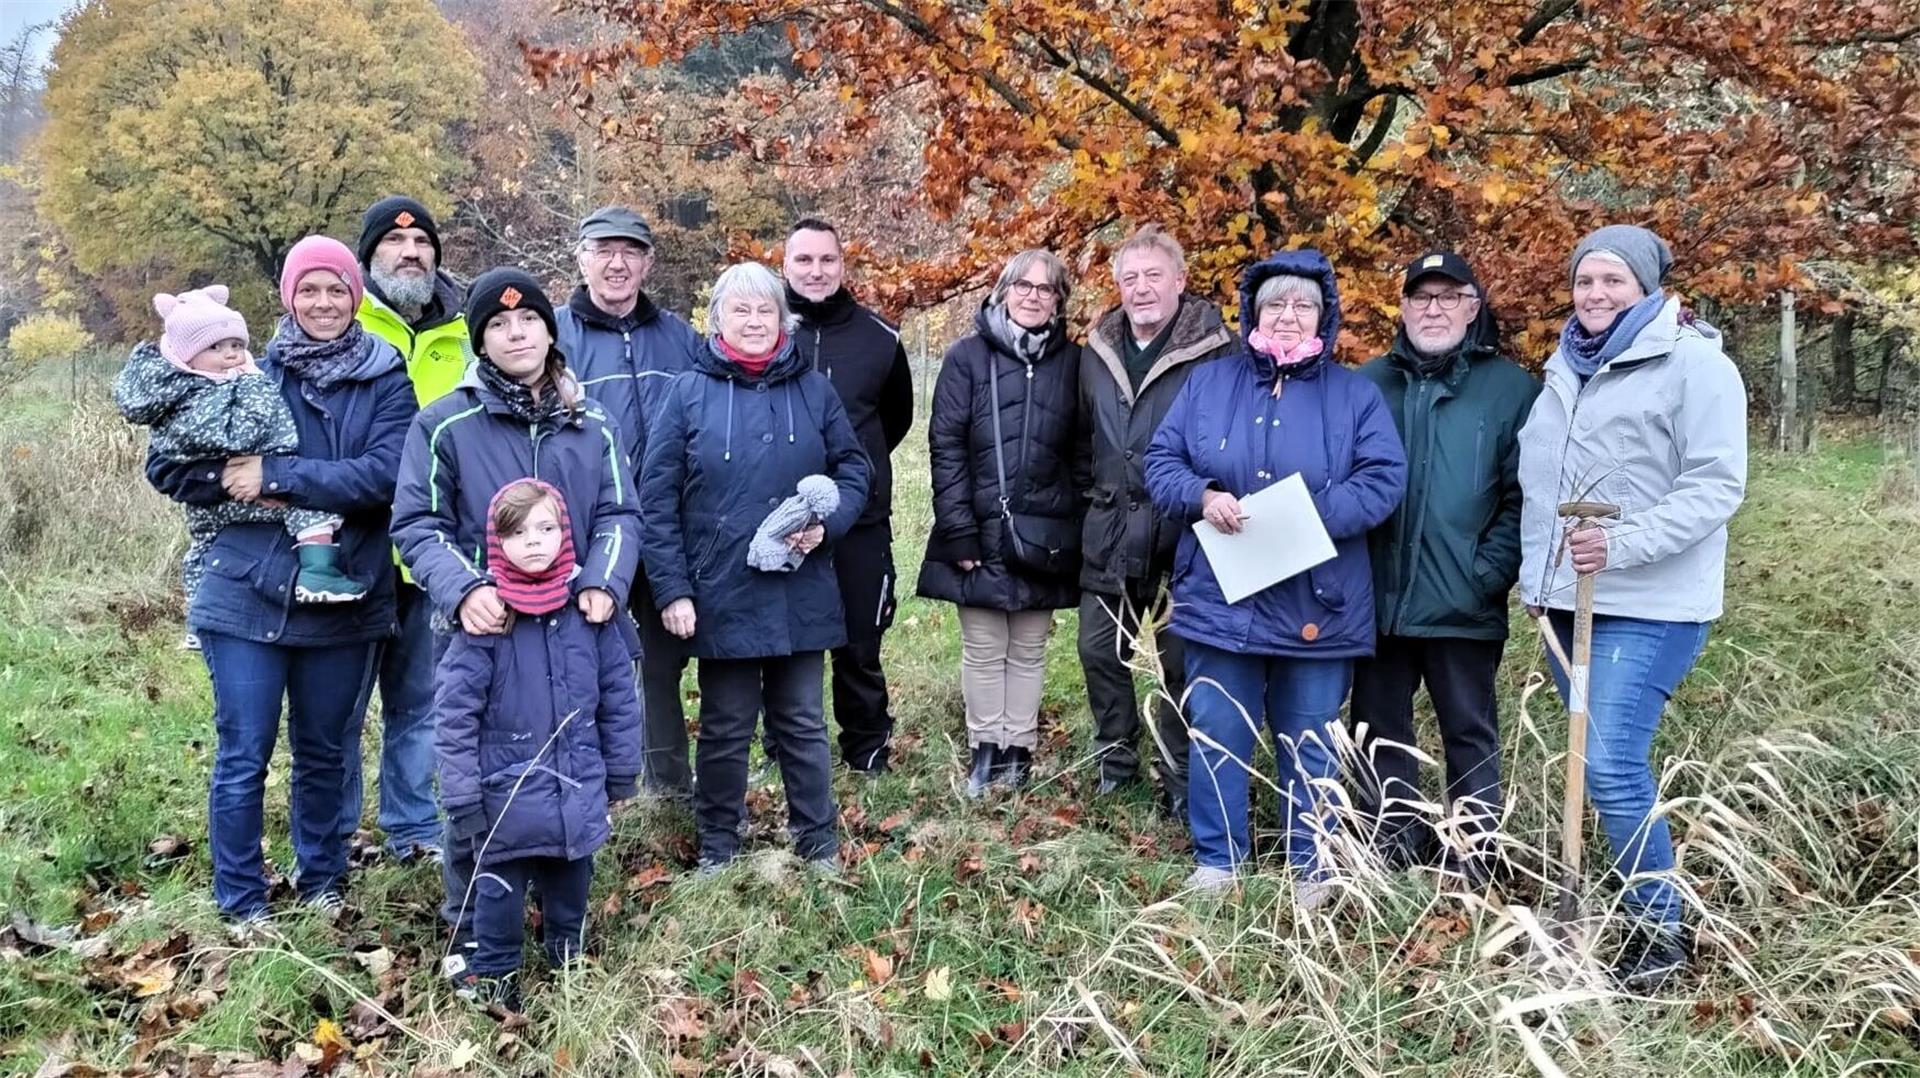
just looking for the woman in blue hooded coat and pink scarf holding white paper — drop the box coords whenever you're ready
[1146,250,1407,909]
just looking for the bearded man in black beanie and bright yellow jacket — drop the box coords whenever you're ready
[340,194,467,861]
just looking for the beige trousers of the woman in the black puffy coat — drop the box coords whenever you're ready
[960,607,1054,749]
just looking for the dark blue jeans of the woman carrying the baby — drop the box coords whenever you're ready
[200,630,378,917]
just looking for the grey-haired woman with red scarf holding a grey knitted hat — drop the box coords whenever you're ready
[639,263,872,872]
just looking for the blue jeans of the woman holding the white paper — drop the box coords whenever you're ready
[1187,642,1354,878]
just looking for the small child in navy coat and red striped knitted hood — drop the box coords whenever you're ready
[434,478,639,1011]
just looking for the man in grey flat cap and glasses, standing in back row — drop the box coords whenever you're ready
[555,206,705,799]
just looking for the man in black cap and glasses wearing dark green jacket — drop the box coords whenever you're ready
[1352,250,1540,884]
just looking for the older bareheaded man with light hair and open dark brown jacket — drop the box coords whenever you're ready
[1079,225,1236,819]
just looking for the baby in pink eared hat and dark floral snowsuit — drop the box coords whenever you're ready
[113,284,367,622]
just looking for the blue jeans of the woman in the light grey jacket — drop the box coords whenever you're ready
[1548,611,1709,926]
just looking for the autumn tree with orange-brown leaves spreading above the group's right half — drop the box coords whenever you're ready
[528,0,1920,352]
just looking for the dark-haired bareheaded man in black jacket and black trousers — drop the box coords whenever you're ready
[783,217,914,774]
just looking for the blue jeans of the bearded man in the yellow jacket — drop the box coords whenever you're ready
[340,582,447,857]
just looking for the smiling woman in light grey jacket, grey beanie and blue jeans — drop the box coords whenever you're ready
[1521,225,1747,990]
